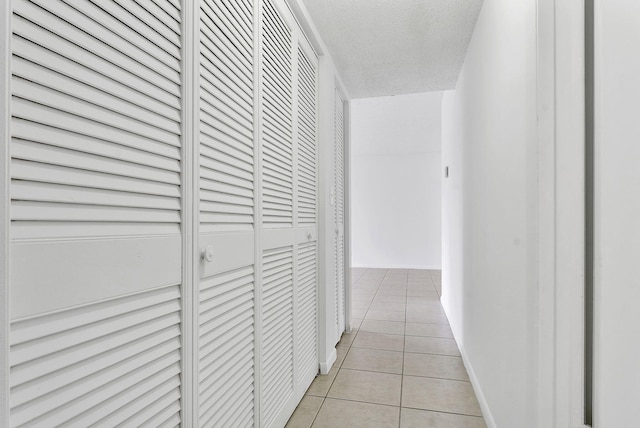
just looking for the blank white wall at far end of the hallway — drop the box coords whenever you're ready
[351,92,442,269]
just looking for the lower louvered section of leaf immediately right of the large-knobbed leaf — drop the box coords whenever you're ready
[261,247,294,426]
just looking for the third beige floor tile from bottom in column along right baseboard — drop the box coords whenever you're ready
[403,352,469,381]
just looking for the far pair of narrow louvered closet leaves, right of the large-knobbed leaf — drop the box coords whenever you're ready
[259,0,318,427]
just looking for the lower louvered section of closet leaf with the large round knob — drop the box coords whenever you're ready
[199,267,255,427]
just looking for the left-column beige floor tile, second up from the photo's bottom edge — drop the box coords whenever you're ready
[327,369,402,406]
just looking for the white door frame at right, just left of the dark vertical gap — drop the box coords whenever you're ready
[531,0,585,428]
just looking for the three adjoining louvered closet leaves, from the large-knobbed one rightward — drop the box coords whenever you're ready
[199,0,318,427]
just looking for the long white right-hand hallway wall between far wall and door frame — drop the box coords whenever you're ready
[442,0,537,428]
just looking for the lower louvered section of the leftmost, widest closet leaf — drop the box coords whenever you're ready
[10,286,181,427]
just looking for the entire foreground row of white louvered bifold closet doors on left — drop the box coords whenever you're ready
[7,0,318,427]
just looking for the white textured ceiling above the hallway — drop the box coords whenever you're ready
[303,0,482,98]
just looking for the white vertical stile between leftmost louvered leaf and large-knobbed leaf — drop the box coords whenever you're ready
[181,1,200,426]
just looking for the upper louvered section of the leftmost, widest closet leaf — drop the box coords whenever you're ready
[11,0,180,239]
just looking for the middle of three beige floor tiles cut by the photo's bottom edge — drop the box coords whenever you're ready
[313,398,400,428]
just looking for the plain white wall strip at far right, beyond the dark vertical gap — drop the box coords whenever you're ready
[593,0,640,428]
